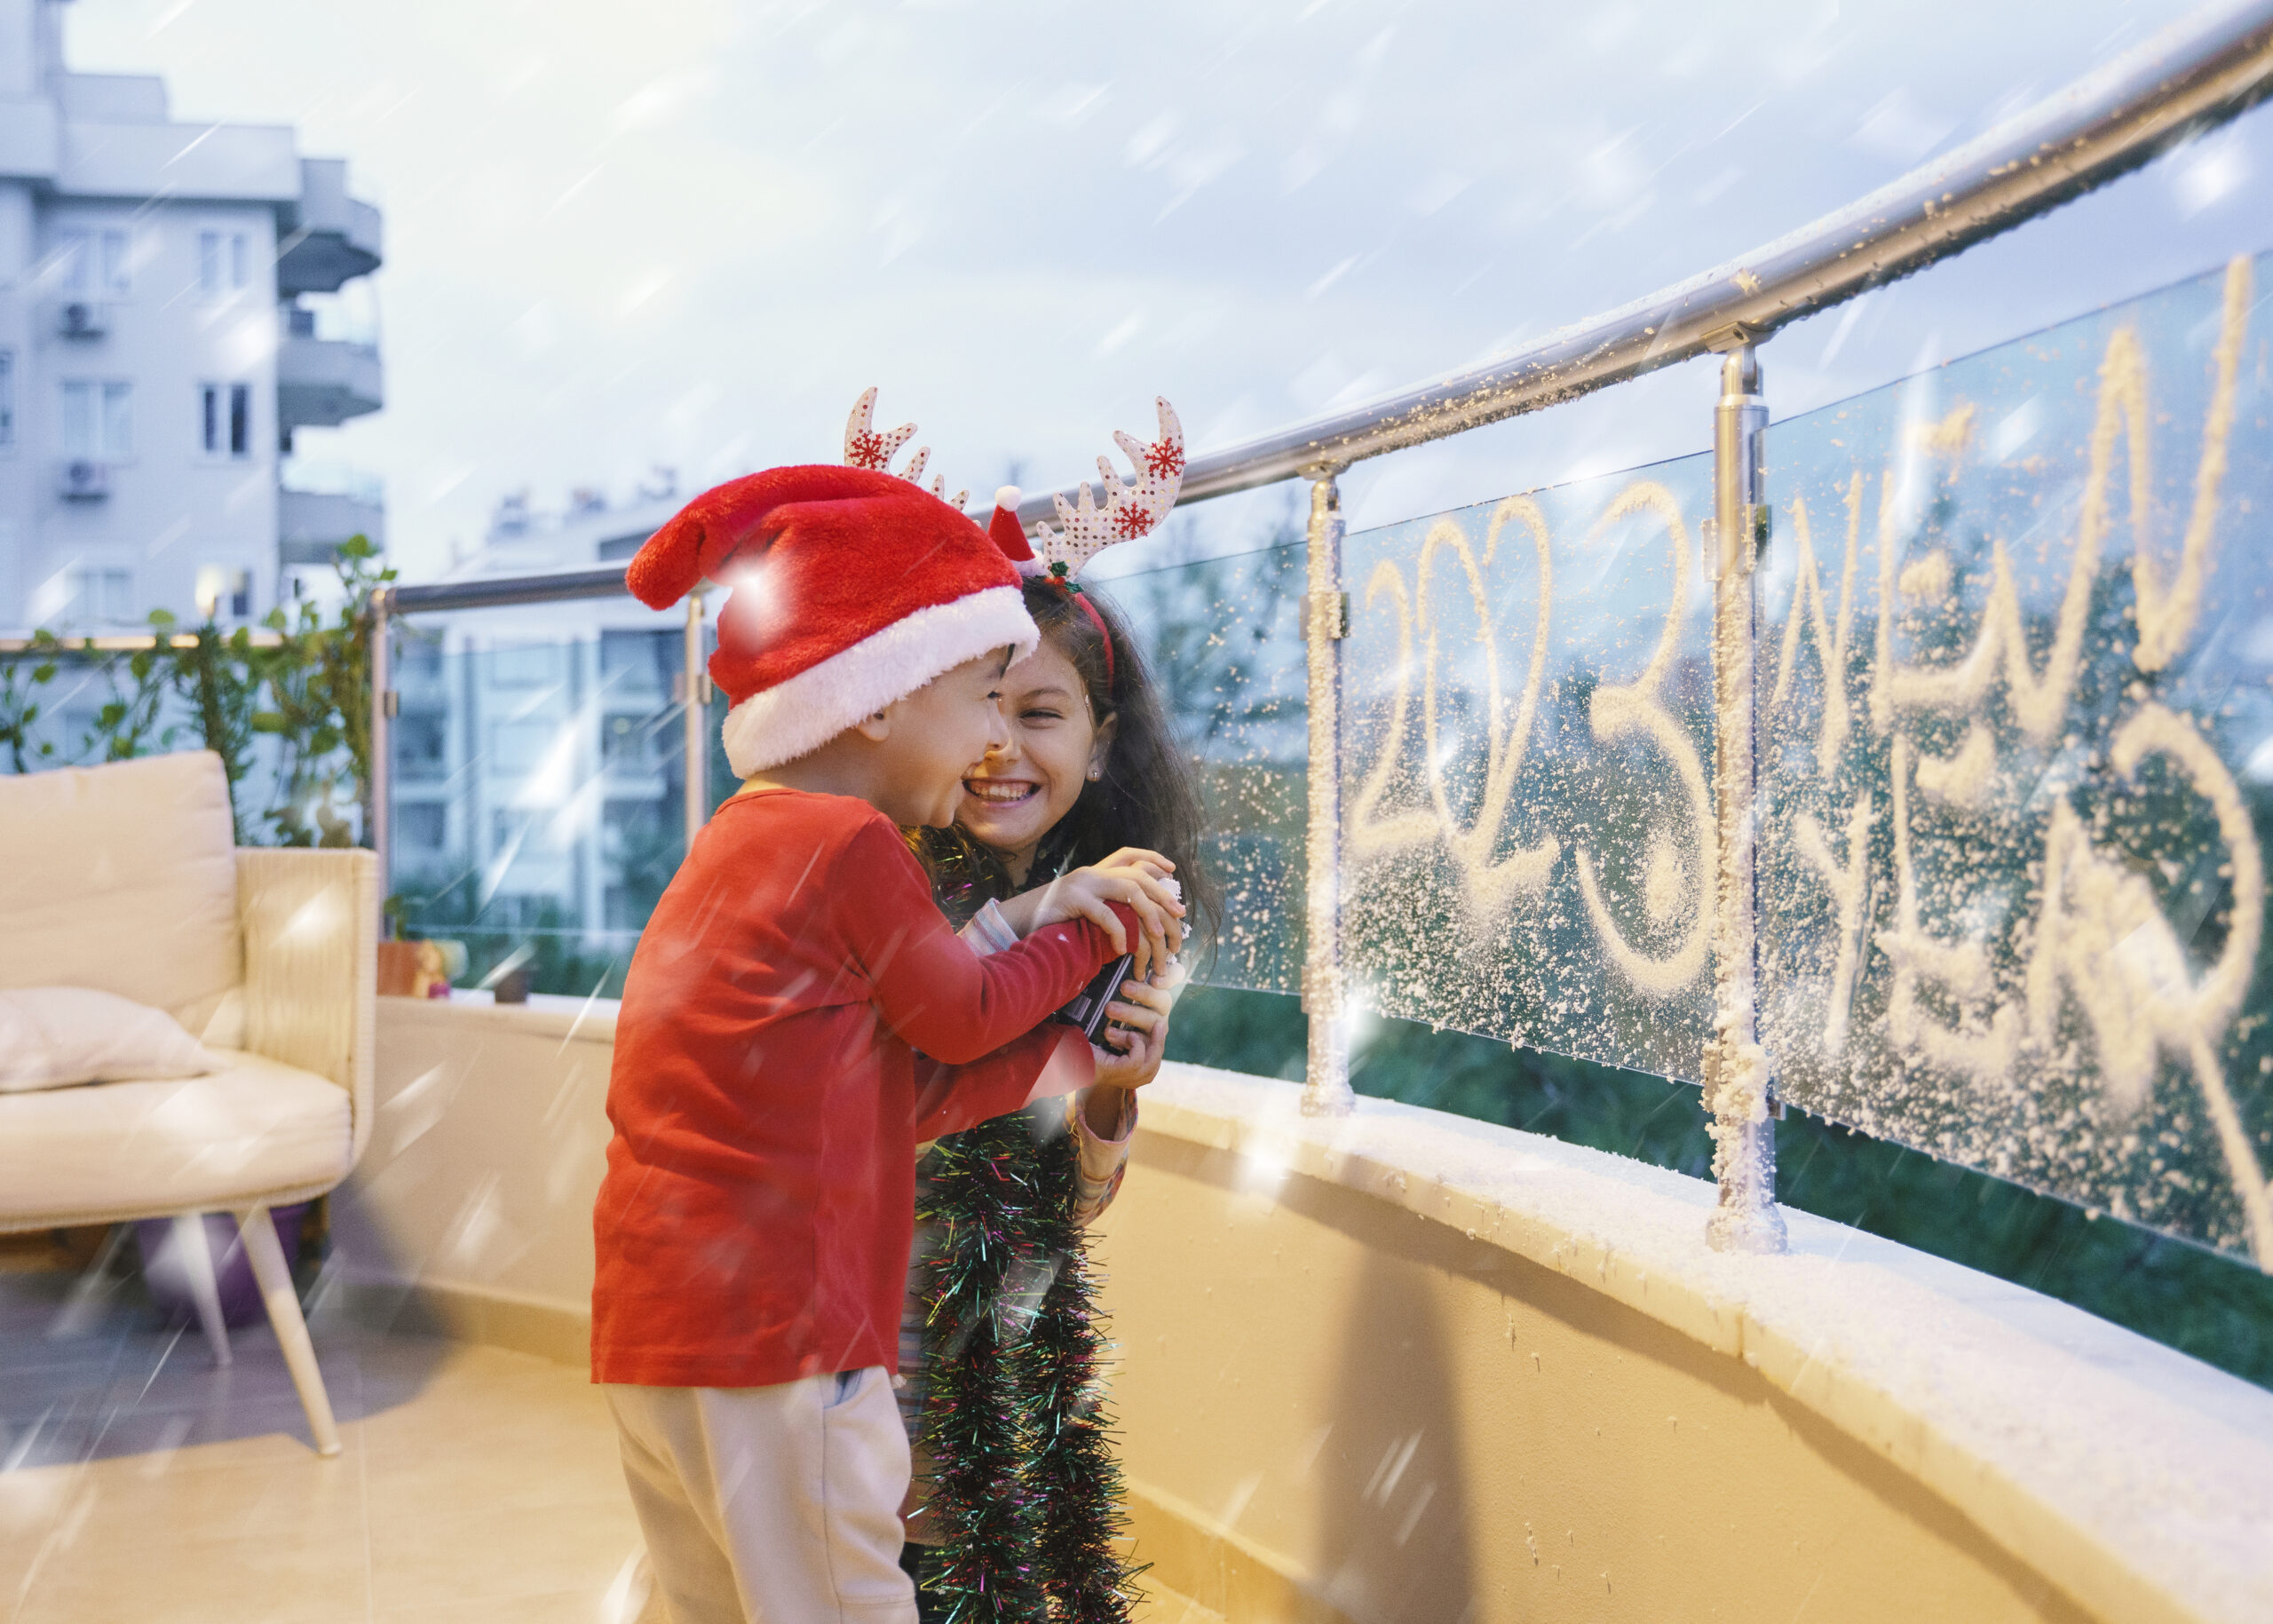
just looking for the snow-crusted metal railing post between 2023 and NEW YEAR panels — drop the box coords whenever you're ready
[1705,332,1785,1251]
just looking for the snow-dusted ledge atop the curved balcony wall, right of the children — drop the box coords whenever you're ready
[1132,1065,2273,1620]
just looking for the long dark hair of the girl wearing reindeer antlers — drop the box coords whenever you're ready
[912,578,1221,963]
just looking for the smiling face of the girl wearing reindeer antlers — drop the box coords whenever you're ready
[959,637,1113,884]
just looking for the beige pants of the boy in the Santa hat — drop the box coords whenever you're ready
[605,1367,916,1624]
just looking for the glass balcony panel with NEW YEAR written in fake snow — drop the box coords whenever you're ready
[1759,246,2273,1260]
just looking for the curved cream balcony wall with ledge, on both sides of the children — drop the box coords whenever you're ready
[334,999,2273,1624]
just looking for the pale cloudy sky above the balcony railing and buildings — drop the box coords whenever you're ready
[66,0,2273,580]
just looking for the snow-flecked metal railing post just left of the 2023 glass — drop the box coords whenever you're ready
[1303,469,1355,1117]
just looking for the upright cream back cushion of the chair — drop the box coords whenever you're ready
[0,750,243,1046]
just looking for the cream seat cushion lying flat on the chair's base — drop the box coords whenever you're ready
[0,1049,352,1224]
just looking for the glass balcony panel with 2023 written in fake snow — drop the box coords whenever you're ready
[1341,457,1714,1078]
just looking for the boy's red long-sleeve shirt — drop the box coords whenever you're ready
[591,789,1128,1388]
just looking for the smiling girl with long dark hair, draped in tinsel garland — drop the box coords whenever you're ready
[900,578,1214,1621]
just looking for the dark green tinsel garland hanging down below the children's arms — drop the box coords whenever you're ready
[918,1114,1134,1624]
